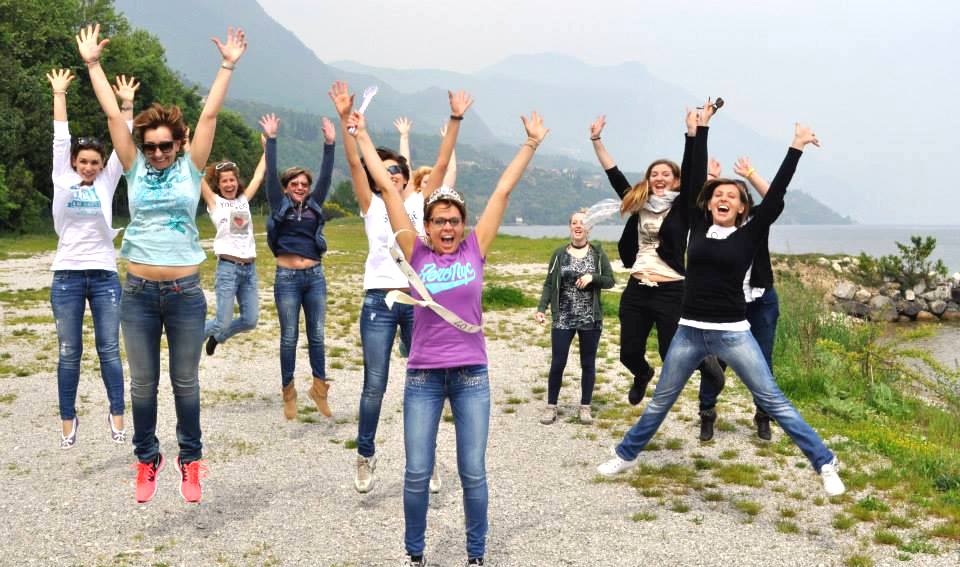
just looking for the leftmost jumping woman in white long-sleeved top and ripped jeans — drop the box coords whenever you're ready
[47,69,140,449]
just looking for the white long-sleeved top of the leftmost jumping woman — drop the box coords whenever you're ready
[50,120,124,272]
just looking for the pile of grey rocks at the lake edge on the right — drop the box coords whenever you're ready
[818,258,960,322]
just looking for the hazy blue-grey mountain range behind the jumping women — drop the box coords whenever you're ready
[115,0,852,224]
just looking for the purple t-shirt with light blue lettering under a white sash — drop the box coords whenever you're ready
[407,231,487,370]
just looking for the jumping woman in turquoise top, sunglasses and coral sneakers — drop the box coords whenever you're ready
[77,24,247,502]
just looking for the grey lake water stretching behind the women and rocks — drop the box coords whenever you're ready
[500,224,960,274]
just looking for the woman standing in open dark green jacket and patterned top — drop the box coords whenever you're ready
[535,209,614,425]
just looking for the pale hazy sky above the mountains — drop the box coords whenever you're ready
[258,0,960,225]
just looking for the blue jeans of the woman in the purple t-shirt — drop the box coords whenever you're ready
[403,366,490,557]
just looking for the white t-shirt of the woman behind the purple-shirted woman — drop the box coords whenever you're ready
[360,193,423,289]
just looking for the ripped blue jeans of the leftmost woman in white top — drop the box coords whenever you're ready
[50,270,124,421]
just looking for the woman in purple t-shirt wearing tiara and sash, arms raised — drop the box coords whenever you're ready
[348,102,548,565]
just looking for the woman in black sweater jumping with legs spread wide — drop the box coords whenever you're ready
[597,114,845,496]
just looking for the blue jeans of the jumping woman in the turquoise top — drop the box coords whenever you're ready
[120,274,207,463]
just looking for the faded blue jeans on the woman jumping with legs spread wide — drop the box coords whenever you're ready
[617,325,833,472]
